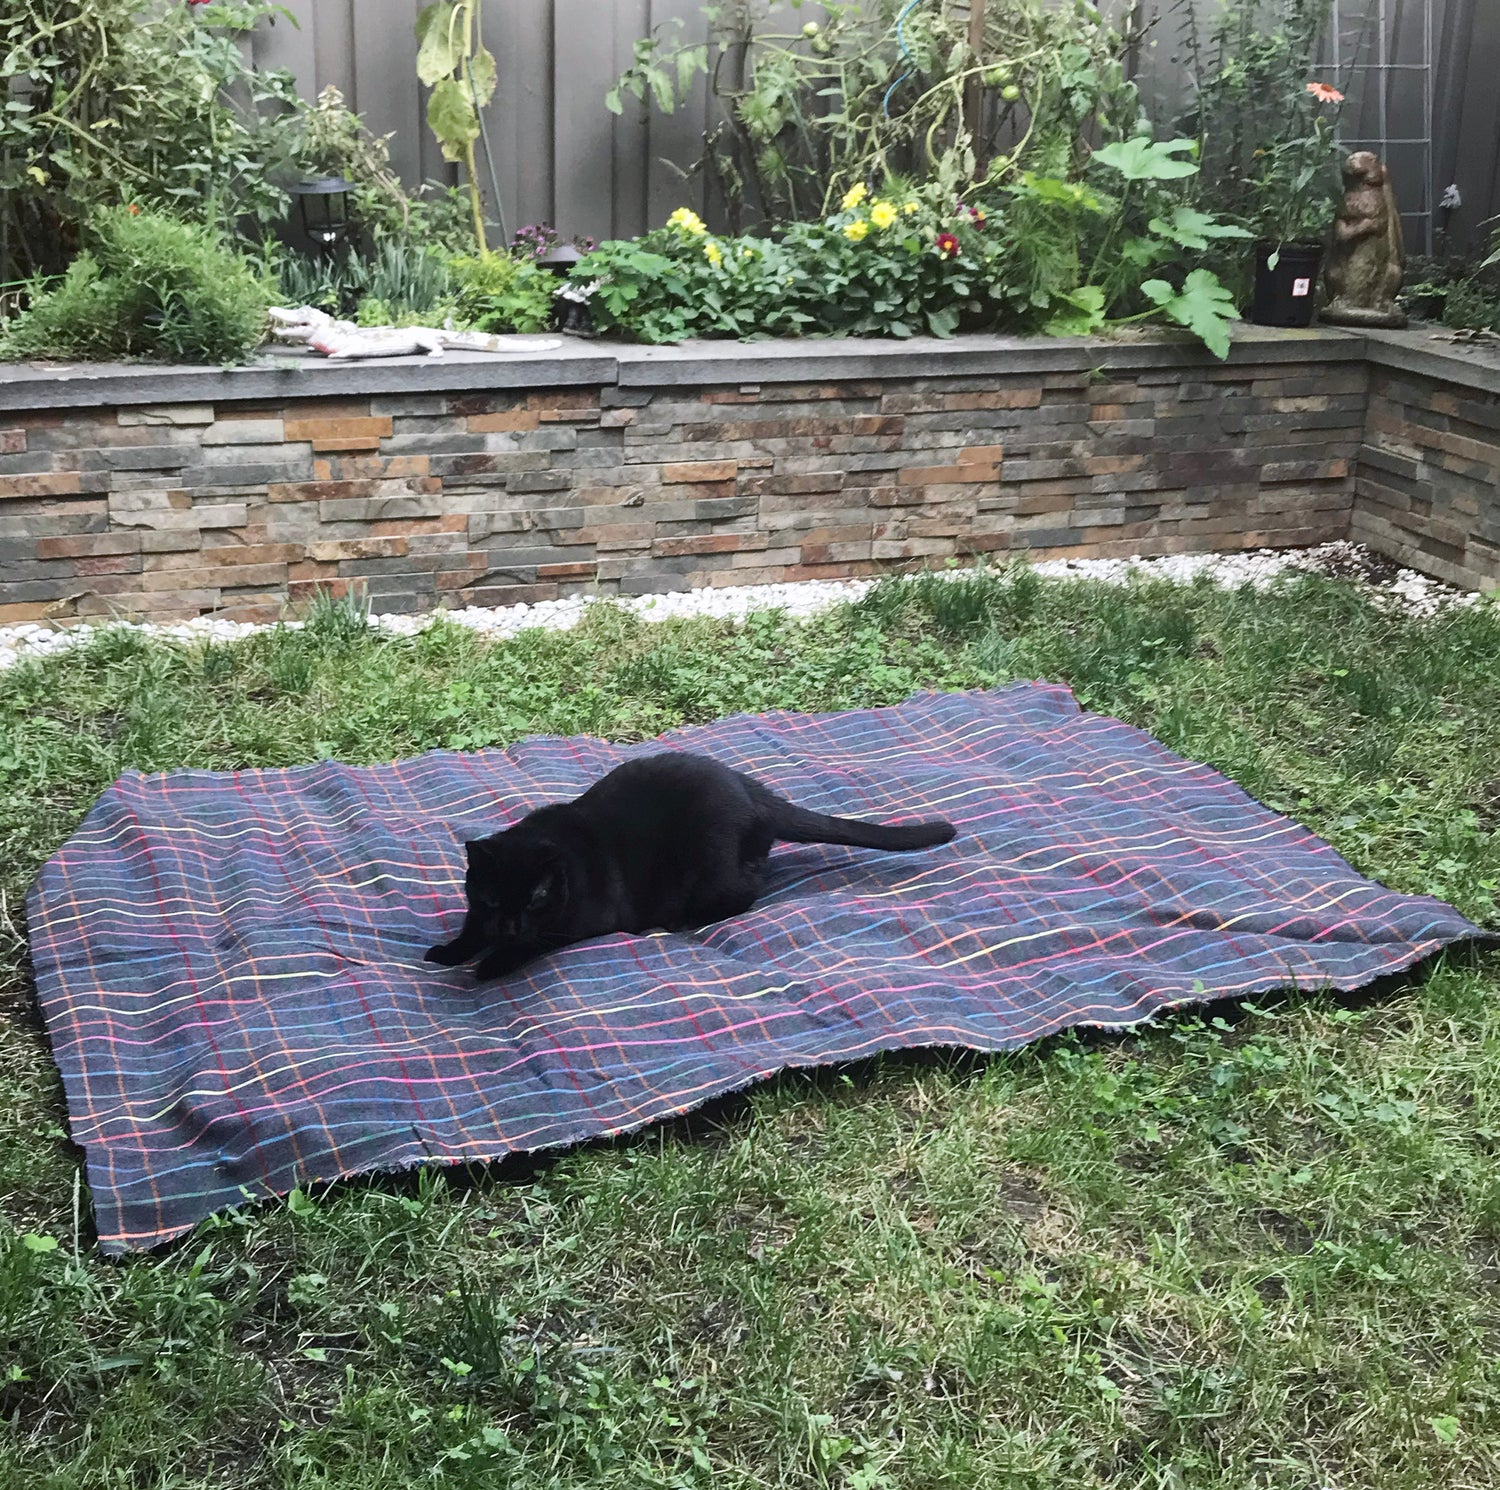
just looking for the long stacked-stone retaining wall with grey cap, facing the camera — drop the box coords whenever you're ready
[0,333,1496,621]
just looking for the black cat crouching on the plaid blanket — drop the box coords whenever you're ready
[428,753,956,980]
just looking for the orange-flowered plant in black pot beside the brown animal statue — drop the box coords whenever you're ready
[1250,83,1344,326]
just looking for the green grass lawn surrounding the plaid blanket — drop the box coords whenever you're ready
[0,572,1500,1490]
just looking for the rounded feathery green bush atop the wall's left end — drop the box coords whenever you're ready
[0,207,272,363]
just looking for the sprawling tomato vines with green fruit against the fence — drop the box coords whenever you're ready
[606,0,1140,230]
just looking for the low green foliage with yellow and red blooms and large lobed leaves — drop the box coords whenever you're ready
[573,169,1247,357]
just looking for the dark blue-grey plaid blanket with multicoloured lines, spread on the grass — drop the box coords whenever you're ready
[29,684,1476,1251]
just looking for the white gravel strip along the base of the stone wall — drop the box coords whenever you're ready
[0,543,1479,669]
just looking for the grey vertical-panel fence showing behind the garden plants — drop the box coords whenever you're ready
[255,0,1500,248]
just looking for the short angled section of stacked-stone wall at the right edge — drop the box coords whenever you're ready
[1352,338,1500,588]
